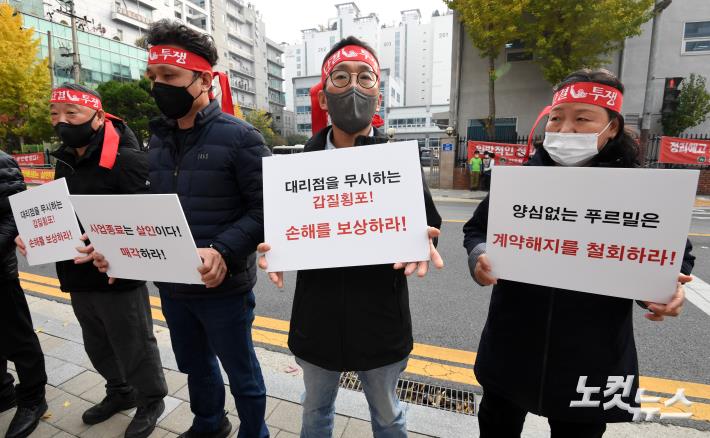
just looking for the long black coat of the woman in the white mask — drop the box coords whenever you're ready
[463,148,695,422]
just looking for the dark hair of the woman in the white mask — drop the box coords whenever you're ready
[552,68,639,167]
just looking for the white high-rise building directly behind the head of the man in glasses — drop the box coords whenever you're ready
[283,2,453,138]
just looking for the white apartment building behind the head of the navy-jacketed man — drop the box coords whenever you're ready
[34,0,285,119]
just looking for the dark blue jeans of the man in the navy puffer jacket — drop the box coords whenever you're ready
[160,290,269,438]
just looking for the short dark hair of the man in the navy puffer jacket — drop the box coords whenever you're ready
[146,19,219,67]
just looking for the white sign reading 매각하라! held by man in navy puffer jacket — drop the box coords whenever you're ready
[70,194,202,284]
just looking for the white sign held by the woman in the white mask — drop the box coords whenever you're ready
[486,166,699,303]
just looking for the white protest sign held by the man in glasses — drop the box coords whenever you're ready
[263,141,429,272]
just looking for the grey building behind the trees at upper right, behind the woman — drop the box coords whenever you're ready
[450,0,710,137]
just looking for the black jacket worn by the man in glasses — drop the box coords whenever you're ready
[288,127,441,371]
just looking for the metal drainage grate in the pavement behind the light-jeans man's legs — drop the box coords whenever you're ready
[340,372,476,415]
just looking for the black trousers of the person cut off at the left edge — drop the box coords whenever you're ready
[0,278,47,407]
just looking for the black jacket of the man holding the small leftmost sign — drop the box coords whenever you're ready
[52,120,149,292]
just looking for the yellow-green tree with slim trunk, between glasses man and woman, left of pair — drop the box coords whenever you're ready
[444,0,530,138]
